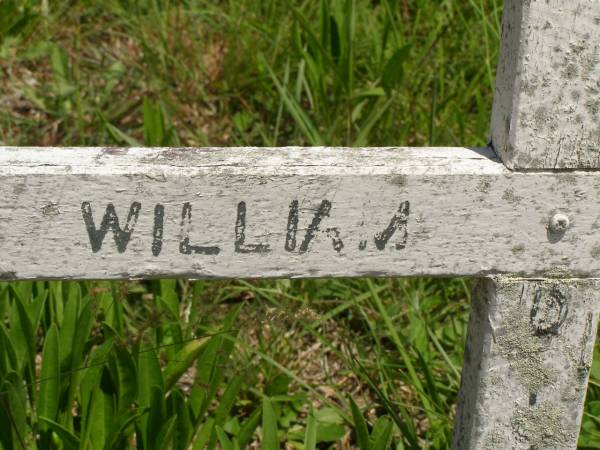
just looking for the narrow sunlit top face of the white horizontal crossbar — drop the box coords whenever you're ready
[0,147,505,176]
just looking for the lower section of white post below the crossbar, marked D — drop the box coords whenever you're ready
[453,278,600,450]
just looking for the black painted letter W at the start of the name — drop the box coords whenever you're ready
[81,202,142,253]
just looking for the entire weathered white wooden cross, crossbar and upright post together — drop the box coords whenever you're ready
[0,0,600,450]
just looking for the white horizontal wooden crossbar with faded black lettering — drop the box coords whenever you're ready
[0,148,600,279]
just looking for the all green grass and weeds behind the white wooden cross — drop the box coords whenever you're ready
[0,0,600,450]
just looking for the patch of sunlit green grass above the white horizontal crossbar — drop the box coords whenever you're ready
[0,0,501,146]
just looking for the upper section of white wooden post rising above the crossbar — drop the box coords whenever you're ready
[492,0,600,169]
